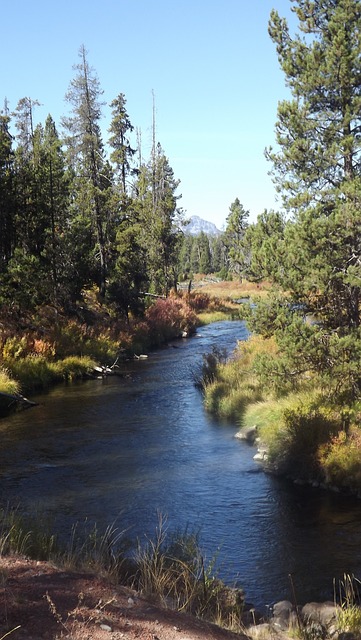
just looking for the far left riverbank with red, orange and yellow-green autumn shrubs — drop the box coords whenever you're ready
[0,282,247,410]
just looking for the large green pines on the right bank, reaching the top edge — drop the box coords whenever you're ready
[246,0,361,396]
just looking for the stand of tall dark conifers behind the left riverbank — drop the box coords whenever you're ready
[0,46,250,316]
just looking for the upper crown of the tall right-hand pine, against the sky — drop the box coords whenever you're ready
[268,0,361,210]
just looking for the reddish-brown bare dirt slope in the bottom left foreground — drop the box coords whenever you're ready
[0,556,246,640]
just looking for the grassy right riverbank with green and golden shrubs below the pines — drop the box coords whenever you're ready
[202,335,361,497]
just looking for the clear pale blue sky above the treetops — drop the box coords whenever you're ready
[0,0,292,228]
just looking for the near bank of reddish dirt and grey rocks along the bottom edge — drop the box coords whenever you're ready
[0,555,361,640]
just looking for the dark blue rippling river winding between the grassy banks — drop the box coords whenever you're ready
[0,322,361,607]
